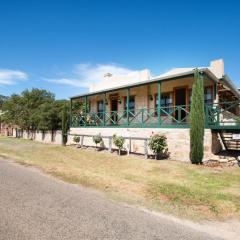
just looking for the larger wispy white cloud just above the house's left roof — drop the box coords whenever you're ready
[45,63,135,88]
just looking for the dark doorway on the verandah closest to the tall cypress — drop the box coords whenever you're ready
[174,88,187,122]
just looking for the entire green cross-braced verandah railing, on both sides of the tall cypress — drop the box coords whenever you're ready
[71,101,240,128]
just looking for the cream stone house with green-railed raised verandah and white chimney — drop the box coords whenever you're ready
[70,59,240,160]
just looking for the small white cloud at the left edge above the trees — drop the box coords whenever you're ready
[0,69,28,85]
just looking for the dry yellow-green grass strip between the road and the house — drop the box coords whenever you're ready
[0,137,240,220]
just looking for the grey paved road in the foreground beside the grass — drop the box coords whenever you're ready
[0,160,223,240]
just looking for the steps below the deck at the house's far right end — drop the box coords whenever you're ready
[219,130,240,151]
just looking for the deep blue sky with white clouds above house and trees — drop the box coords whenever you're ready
[0,0,240,99]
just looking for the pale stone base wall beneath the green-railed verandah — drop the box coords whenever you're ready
[68,128,213,161]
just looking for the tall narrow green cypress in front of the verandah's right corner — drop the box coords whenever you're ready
[190,69,205,164]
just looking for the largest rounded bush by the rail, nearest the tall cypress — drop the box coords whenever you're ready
[148,134,167,159]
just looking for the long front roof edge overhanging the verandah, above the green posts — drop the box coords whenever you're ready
[70,68,219,99]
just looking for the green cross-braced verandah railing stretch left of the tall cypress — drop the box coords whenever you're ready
[71,106,189,127]
